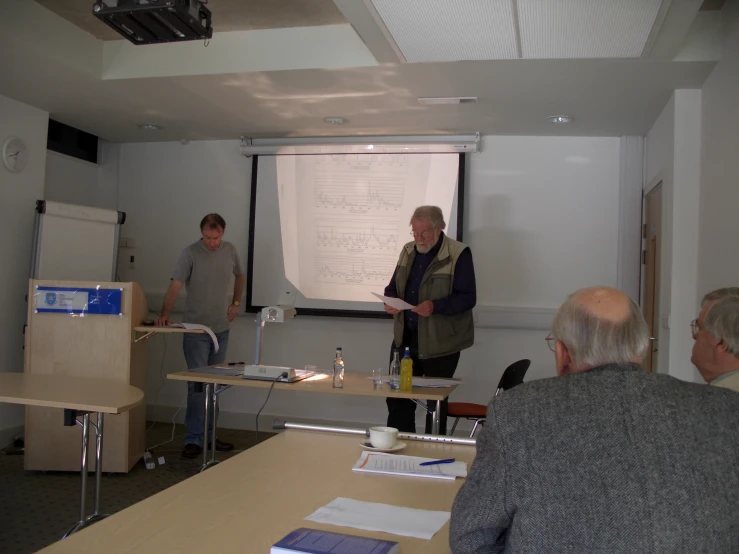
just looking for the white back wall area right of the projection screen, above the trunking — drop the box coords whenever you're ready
[472,137,620,308]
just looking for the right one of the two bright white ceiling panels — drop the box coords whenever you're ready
[517,0,662,59]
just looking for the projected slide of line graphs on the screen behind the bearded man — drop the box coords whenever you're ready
[276,146,459,303]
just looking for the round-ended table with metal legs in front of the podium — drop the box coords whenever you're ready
[0,373,144,537]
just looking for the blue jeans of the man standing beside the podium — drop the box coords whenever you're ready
[182,331,228,446]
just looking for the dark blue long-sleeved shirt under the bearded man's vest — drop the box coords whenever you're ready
[385,234,477,331]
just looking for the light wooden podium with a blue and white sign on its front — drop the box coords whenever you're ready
[24,279,148,473]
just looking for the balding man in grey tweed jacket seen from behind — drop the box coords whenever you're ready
[450,288,739,554]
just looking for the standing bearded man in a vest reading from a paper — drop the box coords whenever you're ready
[385,206,477,435]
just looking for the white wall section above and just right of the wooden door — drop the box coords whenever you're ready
[645,90,701,382]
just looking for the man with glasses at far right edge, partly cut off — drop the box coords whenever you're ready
[690,287,739,392]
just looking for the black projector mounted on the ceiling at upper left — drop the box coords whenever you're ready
[92,0,213,44]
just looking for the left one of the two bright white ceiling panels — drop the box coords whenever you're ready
[372,0,518,62]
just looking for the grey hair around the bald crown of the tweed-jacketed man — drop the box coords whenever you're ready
[552,292,649,367]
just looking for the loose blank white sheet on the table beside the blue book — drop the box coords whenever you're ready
[305,498,450,539]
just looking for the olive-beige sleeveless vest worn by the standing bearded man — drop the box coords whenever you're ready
[393,235,475,359]
